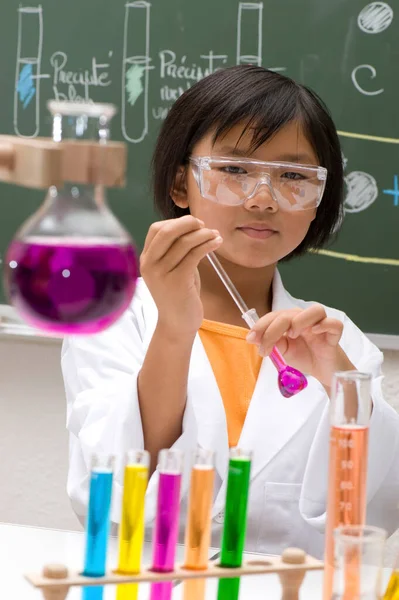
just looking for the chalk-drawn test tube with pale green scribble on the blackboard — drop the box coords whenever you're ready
[121,0,153,144]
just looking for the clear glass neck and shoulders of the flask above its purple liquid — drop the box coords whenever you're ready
[12,101,131,245]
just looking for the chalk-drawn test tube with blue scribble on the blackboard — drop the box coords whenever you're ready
[14,5,43,138]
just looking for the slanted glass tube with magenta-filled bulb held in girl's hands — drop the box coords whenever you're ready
[207,252,308,398]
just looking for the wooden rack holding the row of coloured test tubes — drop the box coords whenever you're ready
[25,548,324,600]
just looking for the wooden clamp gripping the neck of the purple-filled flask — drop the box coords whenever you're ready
[0,135,127,189]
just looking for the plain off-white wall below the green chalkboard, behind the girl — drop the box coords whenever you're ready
[0,325,399,564]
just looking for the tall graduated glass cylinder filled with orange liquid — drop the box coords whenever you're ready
[323,371,371,600]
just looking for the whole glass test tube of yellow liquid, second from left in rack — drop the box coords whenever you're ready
[117,450,150,600]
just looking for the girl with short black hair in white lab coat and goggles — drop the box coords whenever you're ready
[62,66,399,556]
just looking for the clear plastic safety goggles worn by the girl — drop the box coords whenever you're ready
[189,156,327,211]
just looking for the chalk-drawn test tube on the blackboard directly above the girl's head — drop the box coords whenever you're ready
[237,2,263,67]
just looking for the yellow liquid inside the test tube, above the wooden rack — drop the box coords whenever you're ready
[118,465,148,573]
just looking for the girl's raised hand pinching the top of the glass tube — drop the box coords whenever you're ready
[140,215,223,337]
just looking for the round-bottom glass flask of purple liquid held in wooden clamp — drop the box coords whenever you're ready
[5,102,139,335]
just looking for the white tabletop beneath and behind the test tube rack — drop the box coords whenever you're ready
[0,523,391,600]
